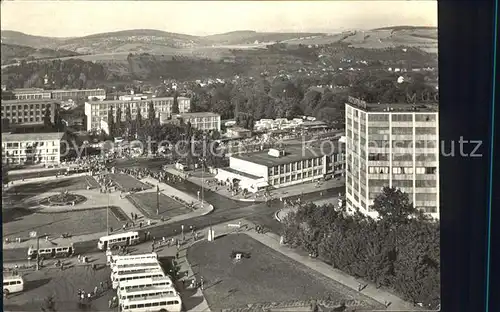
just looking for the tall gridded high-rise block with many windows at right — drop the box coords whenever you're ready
[345,97,439,218]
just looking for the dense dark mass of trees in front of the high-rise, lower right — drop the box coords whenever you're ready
[282,187,440,309]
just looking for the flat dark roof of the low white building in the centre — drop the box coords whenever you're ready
[231,141,343,167]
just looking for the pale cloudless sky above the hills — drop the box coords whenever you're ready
[1,0,437,37]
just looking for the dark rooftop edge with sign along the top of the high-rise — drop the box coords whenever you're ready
[346,97,439,113]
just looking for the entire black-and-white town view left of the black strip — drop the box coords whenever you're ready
[1,0,438,312]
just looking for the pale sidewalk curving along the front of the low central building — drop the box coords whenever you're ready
[166,166,345,202]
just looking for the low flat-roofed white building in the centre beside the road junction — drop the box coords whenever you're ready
[216,142,345,193]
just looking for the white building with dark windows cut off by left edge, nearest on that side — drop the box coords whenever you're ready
[2,132,65,165]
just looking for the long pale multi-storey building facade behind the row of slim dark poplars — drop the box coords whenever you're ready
[85,97,191,131]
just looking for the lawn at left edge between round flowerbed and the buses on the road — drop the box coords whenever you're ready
[2,208,122,238]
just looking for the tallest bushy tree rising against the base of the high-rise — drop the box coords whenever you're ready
[371,186,418,224]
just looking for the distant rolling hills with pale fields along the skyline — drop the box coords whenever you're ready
[2,26,437,56]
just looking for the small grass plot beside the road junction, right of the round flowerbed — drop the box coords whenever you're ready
[127,191,191,219]
